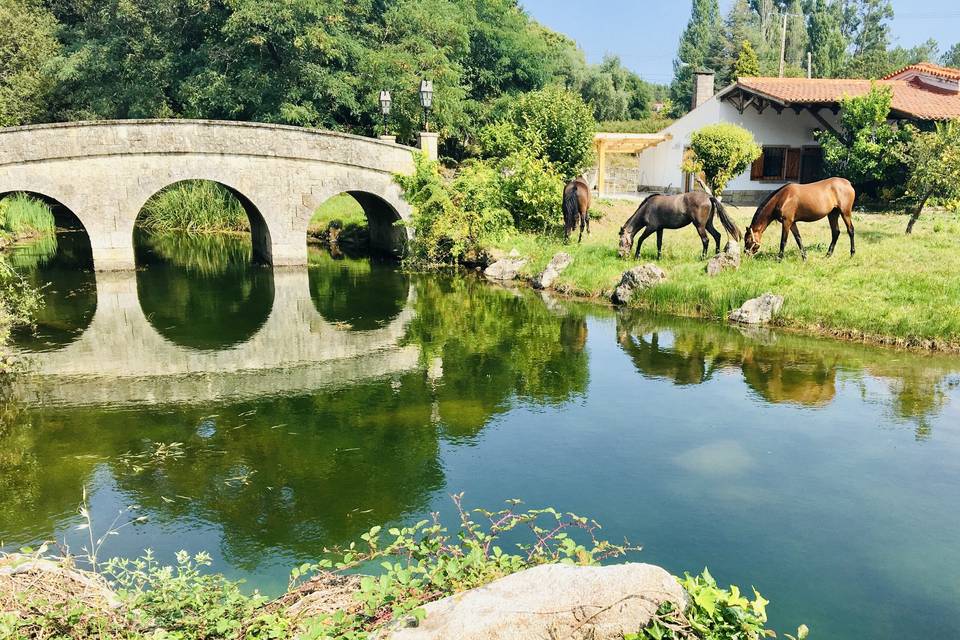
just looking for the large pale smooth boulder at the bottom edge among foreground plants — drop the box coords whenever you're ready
[384,564,688,640]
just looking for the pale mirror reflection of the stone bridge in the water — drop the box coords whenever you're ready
[14,269,420,406]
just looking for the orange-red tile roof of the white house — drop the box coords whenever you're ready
[735,68,960,120]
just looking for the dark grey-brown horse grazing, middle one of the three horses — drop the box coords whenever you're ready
[619,191,740,259]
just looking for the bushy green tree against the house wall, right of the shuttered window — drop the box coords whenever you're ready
[819,85,909,196]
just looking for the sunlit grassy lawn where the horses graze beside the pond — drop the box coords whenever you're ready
[497,202,960,350]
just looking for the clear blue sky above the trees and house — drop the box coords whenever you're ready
[521,0,960,82]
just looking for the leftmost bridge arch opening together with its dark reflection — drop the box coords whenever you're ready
[0,191,97,352]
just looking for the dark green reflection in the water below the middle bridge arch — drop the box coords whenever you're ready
[135,232,274,349]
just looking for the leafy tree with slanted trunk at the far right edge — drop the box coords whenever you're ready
[904,121,960,233]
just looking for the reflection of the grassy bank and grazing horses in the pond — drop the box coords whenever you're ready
[617,312,953,437]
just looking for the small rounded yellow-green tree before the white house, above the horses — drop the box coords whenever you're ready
[683,123,761,195]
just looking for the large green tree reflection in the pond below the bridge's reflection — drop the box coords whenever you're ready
[0,278,587,568]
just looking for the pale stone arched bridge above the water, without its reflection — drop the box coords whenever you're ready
[0,120,413,271]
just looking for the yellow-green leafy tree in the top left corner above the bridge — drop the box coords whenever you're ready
[0,0,60,127]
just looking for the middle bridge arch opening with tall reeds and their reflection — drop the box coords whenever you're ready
[134,180,274,351]
